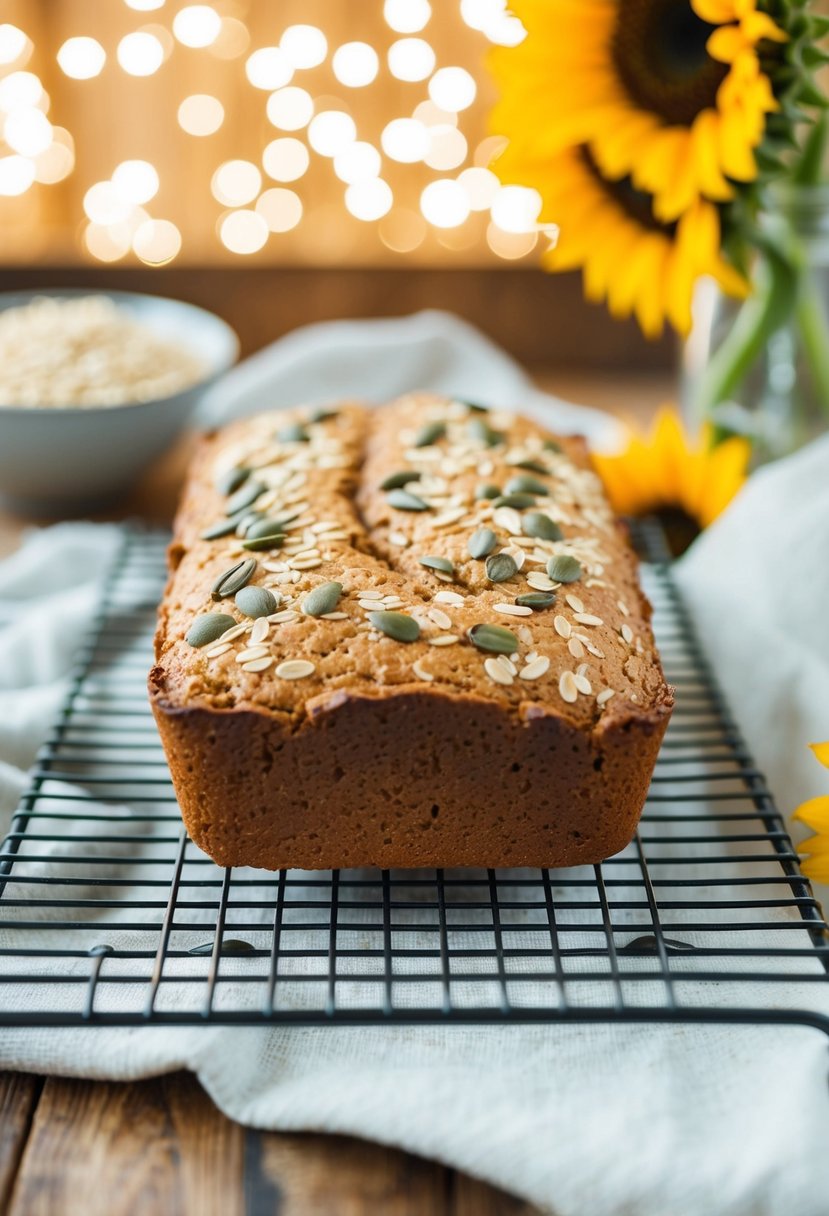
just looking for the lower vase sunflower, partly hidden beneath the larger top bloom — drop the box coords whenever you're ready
[498,139,748,337]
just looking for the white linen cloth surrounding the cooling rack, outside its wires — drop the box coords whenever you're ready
[0,314,829,1216]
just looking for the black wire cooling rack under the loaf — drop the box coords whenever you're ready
[0,524,829,1032]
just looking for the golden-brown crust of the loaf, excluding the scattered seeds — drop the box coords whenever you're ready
[150,394,672,869]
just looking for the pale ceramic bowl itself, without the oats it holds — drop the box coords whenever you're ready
[0,288,238,516]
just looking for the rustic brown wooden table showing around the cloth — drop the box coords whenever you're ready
[0,373,670,1216]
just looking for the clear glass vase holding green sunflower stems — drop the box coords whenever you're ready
[683,185,829,466]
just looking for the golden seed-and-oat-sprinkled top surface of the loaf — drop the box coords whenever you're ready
[152,393,671,730]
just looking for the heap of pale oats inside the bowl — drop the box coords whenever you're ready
[0,295,207,409]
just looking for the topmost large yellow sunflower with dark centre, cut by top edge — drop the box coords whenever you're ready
[491,0,788,223]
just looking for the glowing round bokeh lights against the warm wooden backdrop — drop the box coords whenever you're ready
[0,0,552,266]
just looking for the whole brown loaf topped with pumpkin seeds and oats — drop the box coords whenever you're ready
[150,393,672,869]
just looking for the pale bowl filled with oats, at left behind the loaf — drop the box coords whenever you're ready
[0,289,238,516]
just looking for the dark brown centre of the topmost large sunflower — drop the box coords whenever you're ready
[610,0,728,126]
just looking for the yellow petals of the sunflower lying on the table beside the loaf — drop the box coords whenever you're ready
[593,406,753,539]
